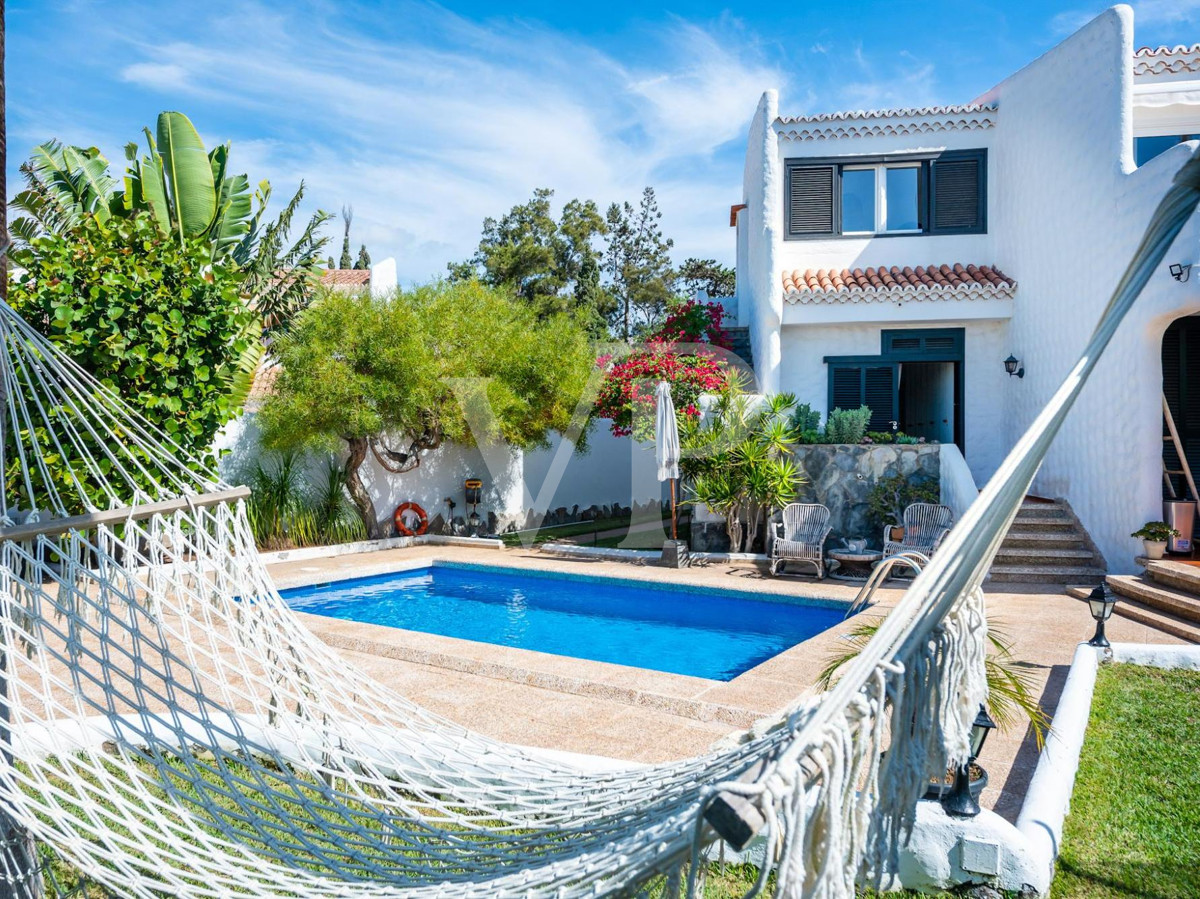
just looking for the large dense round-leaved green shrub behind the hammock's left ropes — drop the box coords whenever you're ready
[8,215,259,504]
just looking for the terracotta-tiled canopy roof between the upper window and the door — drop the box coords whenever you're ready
[782,263,1016,302]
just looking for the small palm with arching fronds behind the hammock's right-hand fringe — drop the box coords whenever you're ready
[817,616,1050,749]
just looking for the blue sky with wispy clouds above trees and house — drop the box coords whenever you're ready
[7,0,1200,281]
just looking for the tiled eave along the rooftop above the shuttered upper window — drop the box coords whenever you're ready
[775,103,996,140]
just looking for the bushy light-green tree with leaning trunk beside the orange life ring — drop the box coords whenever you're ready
[262,281,594,538]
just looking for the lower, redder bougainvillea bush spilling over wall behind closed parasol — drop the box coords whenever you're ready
[596,341,730,440]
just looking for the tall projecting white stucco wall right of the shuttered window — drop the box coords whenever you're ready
[988,7,1200,571]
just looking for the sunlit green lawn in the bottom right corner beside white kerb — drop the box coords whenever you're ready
[1050,665,1200,899]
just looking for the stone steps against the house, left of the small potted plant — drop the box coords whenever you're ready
[988,499,1105,587]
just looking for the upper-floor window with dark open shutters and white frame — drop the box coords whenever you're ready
[787,150,988,238]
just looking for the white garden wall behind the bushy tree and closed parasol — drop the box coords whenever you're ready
[216,413,662,532]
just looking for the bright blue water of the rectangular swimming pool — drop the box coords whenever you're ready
[282,564,844,681]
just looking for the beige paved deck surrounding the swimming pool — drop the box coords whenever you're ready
[269,546,1181,820]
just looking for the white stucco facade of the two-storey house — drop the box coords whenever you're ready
[739,6,1200,571]
